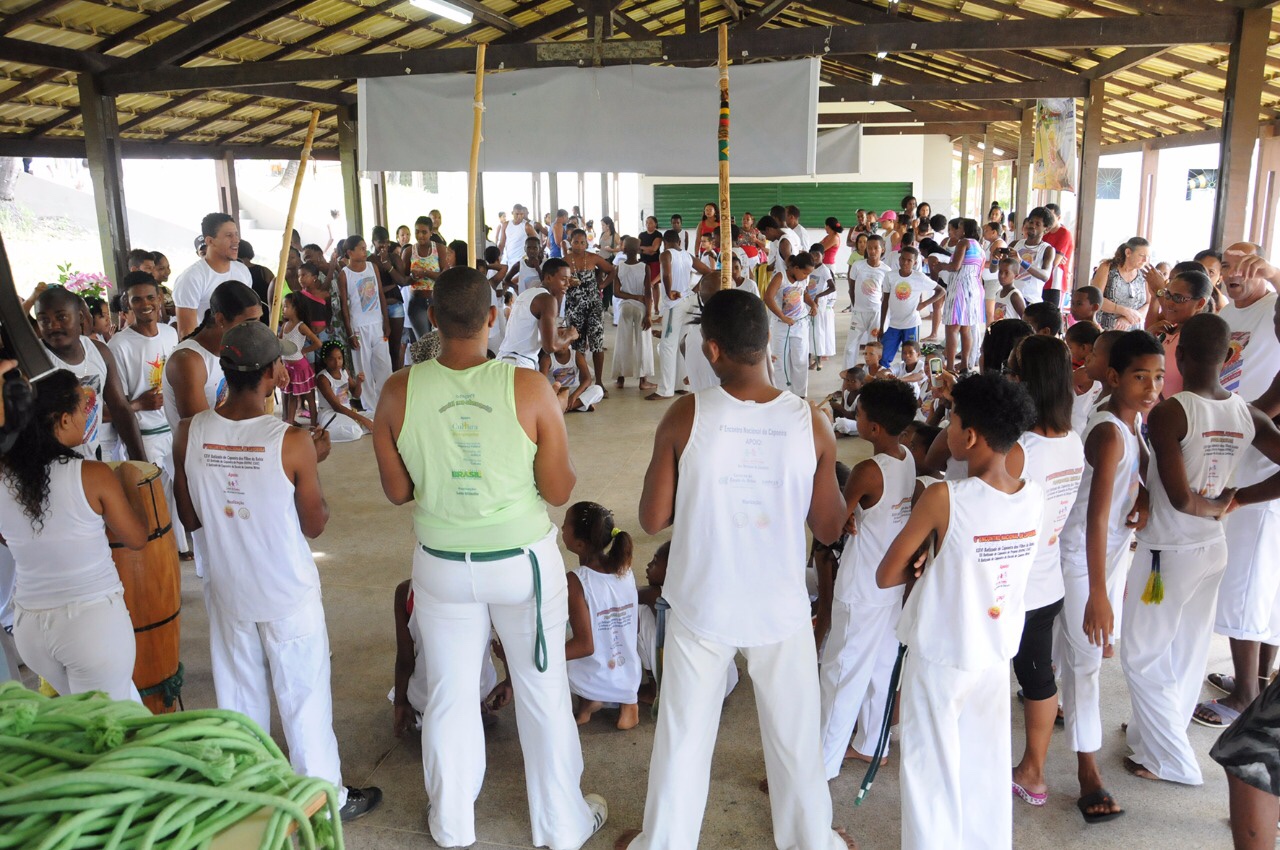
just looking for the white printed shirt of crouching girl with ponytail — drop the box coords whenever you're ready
[568,567,640,705]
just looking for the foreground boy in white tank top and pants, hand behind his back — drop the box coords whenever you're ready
[880,373,1044,850]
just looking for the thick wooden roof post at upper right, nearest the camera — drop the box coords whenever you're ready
[1212,8,1272,251]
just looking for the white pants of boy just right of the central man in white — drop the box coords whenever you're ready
[818,599,902,780]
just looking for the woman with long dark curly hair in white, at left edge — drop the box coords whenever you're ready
[0,370,147,702]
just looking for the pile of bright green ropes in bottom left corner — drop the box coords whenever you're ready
[0,686,343,850]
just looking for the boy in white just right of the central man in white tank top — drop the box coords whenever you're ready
[819,380,919,780]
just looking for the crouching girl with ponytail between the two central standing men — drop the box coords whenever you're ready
[561,502,640,730]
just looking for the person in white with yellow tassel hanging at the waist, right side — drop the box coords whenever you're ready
[1120,314,1280,785]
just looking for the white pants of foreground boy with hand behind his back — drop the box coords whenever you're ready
[900,653,1014,850]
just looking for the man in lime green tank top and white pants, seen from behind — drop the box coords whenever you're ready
[374,266,608,850]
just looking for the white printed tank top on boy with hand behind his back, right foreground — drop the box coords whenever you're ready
[897,477,1044,672]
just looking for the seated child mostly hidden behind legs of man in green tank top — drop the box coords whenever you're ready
[387,579,512,737]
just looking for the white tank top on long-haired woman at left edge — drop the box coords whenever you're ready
[0,460,124,611]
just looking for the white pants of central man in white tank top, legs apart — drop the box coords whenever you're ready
[628,614,845,850]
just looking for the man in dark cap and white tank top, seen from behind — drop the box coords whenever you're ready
[174,321,383,821]
